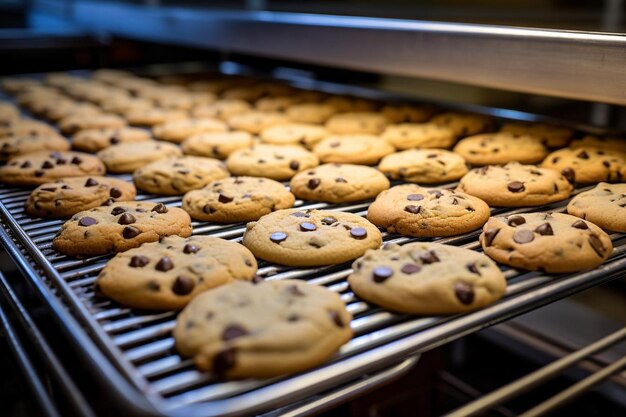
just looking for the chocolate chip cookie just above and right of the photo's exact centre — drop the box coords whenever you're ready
[289,164,389,203]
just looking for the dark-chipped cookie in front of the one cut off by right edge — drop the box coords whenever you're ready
[480,213,613,273]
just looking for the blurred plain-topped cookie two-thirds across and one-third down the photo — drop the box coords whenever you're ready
[381,123,457,150]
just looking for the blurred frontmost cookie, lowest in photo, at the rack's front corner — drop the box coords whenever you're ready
[173,280,352,378]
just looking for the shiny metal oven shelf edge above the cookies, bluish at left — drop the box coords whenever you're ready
[68,1,626,105]
